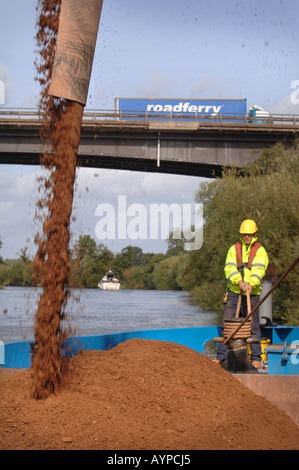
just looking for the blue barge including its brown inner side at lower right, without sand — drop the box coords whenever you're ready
[0,326,299,426]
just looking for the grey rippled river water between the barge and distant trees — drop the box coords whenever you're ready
[0,287,221,343]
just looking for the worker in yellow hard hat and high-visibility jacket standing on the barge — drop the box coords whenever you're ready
[215,219,269,368]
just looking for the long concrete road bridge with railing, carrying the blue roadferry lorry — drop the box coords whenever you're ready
[0,109,299,177]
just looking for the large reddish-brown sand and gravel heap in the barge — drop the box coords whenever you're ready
[0,339,299,450]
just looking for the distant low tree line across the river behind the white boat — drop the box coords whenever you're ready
[0,235,183,289]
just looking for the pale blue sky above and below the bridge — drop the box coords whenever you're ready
[0,0,299,257]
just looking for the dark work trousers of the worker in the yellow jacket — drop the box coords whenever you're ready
[217,291,262,361]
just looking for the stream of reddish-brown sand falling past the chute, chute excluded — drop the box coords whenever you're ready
[32,0,83,398]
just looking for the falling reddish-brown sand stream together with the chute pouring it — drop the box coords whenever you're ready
[32,0,102,398]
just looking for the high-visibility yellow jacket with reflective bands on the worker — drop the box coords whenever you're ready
[224,237,269,295]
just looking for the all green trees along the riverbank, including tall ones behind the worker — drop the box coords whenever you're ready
[0,141,299,325]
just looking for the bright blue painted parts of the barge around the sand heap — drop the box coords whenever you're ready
[1,326,299,375]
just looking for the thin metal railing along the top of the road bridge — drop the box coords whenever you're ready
[0,107,299,126]
